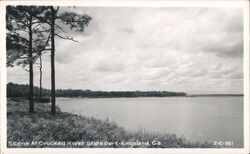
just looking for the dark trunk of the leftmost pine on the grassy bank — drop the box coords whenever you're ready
[29,15,34,113]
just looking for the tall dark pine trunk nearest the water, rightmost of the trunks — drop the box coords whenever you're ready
[50,6,56,115]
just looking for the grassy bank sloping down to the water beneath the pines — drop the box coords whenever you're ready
[7,99,212,148]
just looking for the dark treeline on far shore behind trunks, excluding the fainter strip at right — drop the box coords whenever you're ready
[7,82,186,98]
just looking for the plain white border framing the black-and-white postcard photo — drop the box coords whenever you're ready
[0,0,249,154]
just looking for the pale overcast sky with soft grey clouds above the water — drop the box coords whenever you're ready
[7,7,243,94]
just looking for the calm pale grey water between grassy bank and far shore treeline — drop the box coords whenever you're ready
[57,97,243,147]
